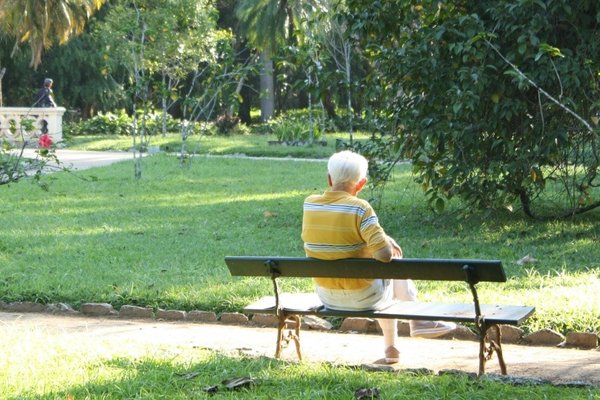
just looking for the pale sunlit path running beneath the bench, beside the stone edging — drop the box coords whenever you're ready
[0,312,600,387]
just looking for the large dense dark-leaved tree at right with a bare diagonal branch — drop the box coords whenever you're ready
[348,0,600,218]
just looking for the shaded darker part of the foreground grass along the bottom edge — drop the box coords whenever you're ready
[6,352,600,400]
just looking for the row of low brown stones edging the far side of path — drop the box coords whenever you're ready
[0,301,599,349]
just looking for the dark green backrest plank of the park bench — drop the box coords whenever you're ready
[225,256,506,283]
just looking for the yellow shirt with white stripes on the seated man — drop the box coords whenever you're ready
[302,191,388,290]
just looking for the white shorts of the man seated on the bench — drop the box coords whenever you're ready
[315,279,394,311]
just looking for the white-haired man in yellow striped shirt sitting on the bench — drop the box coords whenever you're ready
[302,151,456,364]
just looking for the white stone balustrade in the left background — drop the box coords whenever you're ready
[0,107,66,146]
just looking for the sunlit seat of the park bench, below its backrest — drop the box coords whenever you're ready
[244,293,535,325]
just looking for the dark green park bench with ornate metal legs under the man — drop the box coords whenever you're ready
[225,256,535,375]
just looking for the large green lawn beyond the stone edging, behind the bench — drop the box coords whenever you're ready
[0,147,600,333]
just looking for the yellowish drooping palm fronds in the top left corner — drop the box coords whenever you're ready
[0,0,106,68]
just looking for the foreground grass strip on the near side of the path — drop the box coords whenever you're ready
[0,331,600,400]
